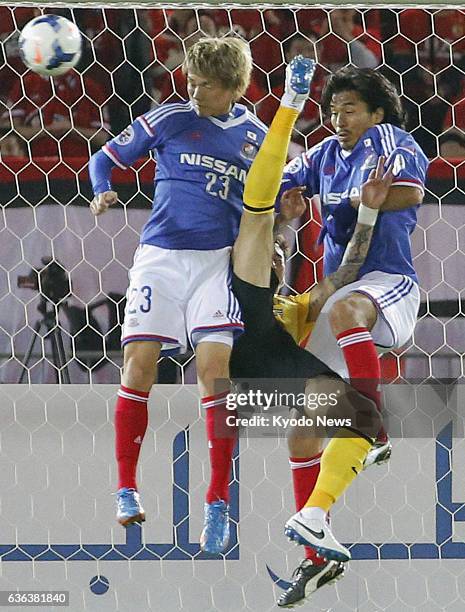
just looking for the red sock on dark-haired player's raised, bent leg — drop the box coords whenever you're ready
[336,327,387,441]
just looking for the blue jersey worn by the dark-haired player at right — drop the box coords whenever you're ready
[281,123,428,281]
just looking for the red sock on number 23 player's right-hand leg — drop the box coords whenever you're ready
[202,391,237,504]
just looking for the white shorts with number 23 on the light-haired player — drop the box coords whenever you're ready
[121,244,244,355]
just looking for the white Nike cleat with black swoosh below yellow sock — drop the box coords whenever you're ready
[284,508,352,561]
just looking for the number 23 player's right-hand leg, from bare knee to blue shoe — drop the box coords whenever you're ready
[196,336,237,554]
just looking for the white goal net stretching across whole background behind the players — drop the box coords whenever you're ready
[0,3,465,612]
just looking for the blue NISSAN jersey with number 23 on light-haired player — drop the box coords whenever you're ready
[103,102,267,250]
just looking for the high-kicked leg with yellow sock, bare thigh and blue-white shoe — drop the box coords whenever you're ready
[233,56,315,287]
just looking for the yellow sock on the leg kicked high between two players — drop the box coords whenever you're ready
[244,106,299,215]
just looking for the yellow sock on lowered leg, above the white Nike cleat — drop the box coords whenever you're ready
[304,432,372,512]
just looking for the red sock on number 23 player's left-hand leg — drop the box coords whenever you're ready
[115,385,149,489]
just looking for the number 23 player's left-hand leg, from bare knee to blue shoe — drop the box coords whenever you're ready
[115,342,161,527]
